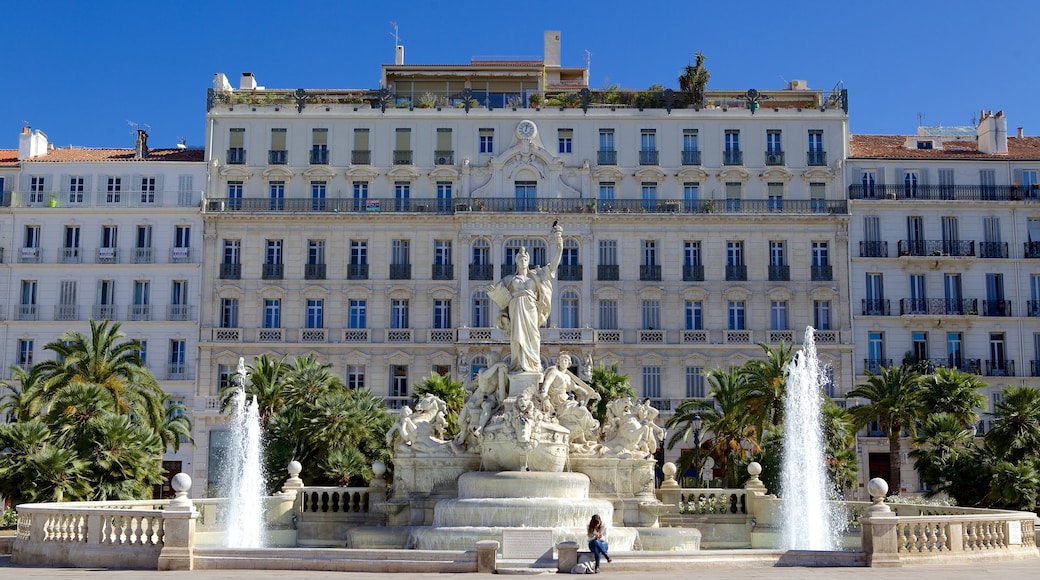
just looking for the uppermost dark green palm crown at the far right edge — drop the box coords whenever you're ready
[986,387,1040,463]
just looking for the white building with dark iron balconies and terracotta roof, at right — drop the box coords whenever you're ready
[846,112,1040,492]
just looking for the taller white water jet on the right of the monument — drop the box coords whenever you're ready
[780,326,844,550]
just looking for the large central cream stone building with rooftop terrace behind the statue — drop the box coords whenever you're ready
[191,33,854,490]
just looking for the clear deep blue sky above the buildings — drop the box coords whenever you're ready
[0,0,1040,148]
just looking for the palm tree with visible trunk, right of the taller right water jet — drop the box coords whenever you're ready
[847,365,925,494]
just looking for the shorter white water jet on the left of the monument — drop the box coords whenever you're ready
[220,358,264,548]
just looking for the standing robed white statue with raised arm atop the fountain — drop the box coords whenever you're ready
[488,222,564,373]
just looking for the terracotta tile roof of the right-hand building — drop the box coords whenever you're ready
[850,135,1040,159]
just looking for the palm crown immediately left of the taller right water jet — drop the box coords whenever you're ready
[743,342,795,433]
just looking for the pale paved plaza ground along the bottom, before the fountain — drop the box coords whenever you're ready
[0,556,1040,580]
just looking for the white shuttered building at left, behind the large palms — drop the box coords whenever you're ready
[0,128,206,494]
